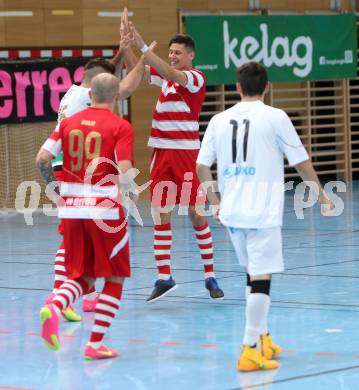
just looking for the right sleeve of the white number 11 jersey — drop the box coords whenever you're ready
[276,111,309,166]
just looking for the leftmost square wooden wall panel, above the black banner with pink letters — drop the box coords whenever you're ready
[3,9,45,47]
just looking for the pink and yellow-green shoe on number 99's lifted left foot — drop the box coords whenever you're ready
[40,305,60,351]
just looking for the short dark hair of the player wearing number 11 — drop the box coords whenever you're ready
[237,61,268,96]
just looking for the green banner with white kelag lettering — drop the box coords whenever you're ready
[186,14,357,84]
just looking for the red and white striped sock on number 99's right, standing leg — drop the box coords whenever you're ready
[89,282,122,349]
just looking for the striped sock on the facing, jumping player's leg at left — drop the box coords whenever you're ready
[153,223,172,280]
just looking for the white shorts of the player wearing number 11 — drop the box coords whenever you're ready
[228,226,284,275]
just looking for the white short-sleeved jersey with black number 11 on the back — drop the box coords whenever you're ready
[197,100,309,229]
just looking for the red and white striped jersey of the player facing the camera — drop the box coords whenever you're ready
[148,67,206,149]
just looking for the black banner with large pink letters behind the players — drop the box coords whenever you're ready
[0,58,88,124]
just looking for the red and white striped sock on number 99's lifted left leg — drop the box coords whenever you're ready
[51,278,88,315]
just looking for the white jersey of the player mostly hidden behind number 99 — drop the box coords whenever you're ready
[52,84,91,167]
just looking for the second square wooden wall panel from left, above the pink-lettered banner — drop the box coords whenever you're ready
[45,9,83,47]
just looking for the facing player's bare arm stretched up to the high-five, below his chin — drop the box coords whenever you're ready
[129,22,187,87]
